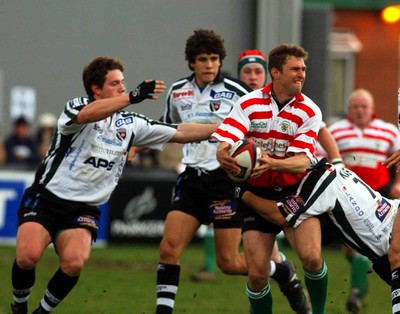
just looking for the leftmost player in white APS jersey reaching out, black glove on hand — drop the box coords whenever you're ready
[11,57,217,314]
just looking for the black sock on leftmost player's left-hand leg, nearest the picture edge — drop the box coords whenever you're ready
[11,260,35,303]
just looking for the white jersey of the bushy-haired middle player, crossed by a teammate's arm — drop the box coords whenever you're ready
[163,73,250,171]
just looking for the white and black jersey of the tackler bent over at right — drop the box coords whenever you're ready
[278,162,400,259]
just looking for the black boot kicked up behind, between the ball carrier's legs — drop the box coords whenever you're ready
[279,261,311,314]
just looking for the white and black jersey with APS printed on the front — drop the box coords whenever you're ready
[34,98,176,205]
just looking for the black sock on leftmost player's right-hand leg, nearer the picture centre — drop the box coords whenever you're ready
[40,268,79,312]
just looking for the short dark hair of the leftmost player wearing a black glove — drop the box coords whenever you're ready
[82,57,124,99]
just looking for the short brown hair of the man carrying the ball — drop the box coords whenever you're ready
[268,44,308,74]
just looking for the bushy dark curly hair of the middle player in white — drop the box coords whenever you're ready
[185,29,226,71]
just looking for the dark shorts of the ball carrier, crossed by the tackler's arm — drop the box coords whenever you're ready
[239,184,298,234]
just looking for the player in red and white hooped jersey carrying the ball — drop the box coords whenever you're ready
[213,44,327,314]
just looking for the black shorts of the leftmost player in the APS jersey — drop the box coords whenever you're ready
[18,186,100,242]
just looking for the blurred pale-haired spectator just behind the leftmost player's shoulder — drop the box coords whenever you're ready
[36,112,57,159]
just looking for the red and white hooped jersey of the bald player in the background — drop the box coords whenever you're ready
[328,118,400,190]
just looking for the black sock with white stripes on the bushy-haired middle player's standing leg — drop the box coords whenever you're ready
[156,263,181,314]
